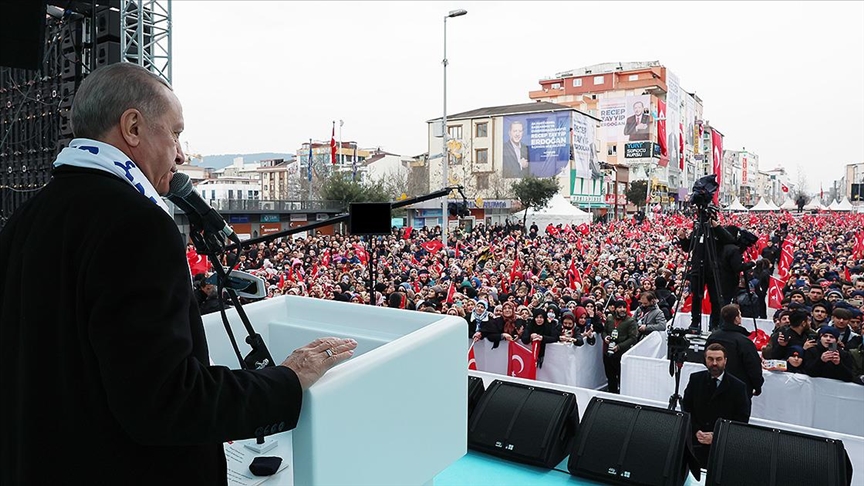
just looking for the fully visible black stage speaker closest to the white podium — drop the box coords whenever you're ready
[468,380,579,468]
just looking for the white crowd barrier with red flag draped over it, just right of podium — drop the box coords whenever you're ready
[474,337,606,389]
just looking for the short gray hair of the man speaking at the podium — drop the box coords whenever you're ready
[71,62,171,139]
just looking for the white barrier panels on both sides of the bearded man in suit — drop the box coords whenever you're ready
[621,332,864,437]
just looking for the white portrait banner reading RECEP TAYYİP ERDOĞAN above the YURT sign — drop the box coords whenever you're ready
[600,95,652,142]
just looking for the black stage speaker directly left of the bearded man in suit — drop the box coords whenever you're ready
[567,397,699,486]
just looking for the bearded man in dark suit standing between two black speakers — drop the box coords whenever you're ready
[681,343,750,468]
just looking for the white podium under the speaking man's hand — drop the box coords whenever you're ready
[204,296,468,486]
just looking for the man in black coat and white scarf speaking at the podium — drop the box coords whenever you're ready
[0,63,356,484]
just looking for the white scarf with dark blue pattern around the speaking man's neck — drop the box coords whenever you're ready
[54,138,171,216]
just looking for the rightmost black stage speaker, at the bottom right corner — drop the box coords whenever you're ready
[705,419,852,486]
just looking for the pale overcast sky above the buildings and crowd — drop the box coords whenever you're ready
[172,0,864,192]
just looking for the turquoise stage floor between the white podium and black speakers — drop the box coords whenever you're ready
[434,450,705,486]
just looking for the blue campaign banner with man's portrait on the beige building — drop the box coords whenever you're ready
[501,111,573,179]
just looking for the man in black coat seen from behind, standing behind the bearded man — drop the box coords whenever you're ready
[707,304,765,397]
